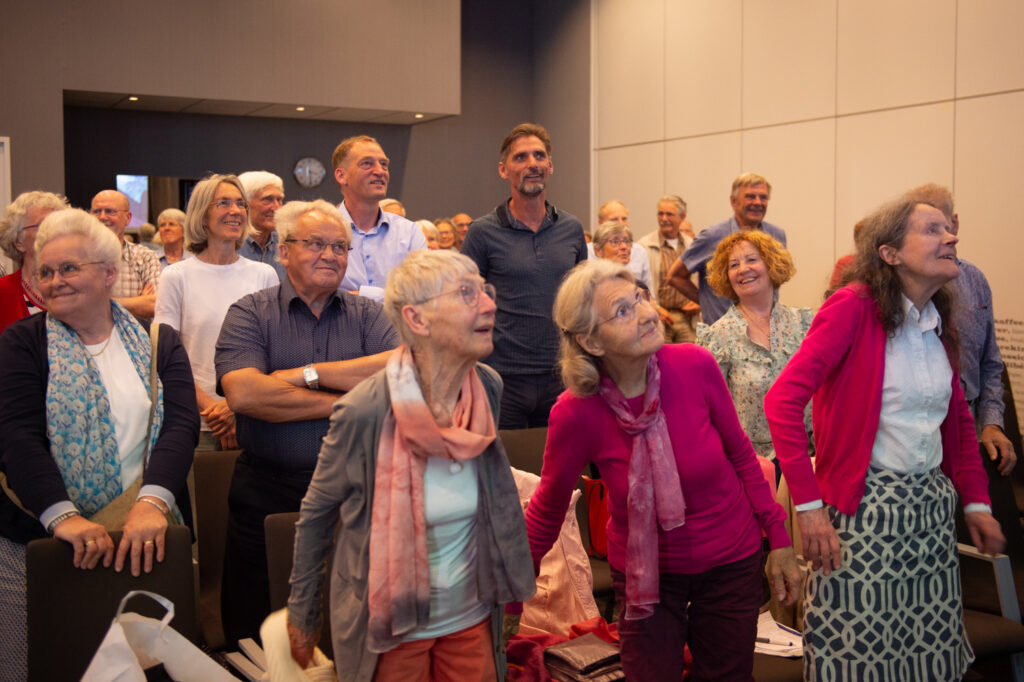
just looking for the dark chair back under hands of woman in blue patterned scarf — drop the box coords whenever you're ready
[26,525,201,682]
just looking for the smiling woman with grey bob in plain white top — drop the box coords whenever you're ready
[154,175,280,450]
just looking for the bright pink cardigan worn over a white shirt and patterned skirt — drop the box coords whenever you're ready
[765,283,988,515]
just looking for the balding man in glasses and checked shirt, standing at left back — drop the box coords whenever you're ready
[90,189,162,319]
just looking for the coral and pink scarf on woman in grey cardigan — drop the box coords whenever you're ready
[367,346,495,653]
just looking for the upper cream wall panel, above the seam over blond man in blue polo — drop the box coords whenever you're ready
[742,0,836,128]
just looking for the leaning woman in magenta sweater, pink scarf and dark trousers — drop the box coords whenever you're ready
[526,260,799,682]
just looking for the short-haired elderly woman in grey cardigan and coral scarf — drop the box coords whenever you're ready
[288,251,535,681]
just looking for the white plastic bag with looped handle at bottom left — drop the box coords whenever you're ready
[82,590,237,682]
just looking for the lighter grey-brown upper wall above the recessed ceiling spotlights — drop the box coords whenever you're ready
[0,0,461,195]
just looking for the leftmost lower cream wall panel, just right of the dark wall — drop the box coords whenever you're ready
[591,142,665,239]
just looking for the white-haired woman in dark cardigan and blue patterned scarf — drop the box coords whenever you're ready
[0,209,199,679]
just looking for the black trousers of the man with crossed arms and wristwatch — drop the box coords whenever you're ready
[220,454,312,650]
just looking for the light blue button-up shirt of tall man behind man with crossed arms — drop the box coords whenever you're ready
[338,202,427,301]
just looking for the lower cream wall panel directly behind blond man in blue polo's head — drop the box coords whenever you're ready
[743,119,837,307]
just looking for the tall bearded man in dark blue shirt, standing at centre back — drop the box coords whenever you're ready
[462,123,587,429]
